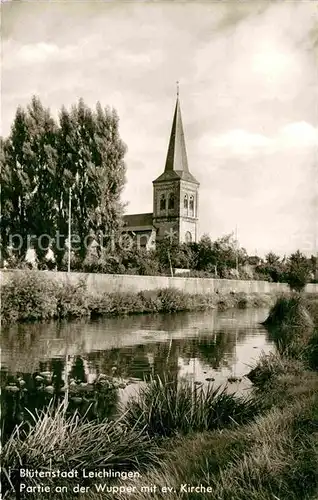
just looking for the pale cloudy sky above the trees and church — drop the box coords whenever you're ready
[1,0,318,255]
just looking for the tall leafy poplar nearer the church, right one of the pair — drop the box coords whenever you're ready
[58,100,126,258]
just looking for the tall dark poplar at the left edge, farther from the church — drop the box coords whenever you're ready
[1,97,57,258]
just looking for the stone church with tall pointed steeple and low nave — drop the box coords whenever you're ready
[122,92,199,249]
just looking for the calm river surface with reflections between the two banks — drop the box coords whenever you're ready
[1,309,273,440]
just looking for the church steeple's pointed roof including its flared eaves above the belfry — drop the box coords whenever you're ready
[153,96,199,184]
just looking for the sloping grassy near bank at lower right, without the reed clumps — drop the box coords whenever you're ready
[82,297,318,500]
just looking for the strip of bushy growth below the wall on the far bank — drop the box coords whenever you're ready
[1,272,274,323]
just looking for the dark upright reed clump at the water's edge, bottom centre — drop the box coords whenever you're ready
[125,378,261,437]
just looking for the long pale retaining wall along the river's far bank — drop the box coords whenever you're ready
[0,270,318,295]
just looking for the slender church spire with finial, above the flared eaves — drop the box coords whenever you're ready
[165,89,189,172]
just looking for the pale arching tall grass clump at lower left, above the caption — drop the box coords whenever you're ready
[1,404,159,498]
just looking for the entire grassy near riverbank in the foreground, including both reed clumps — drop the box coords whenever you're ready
[2,292,318,500]
